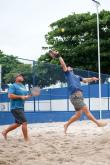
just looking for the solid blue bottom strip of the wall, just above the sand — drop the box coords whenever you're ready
[0,111,110,125]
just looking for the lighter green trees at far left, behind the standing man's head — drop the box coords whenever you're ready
[0,51,33,84]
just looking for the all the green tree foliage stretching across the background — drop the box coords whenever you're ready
[0,11,110,87]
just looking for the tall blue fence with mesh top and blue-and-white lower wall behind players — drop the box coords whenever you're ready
[0,63,110,124]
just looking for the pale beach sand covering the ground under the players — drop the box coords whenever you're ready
[0,120,110,165]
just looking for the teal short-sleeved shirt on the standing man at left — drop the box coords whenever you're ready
[8,83,28,110]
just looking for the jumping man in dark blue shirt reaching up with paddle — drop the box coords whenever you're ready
[49,50,107,134]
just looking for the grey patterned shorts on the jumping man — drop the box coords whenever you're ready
[70,91,86,111]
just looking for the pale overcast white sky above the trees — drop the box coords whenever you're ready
[0,0,110,60]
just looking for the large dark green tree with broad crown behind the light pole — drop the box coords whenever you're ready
[39,10,110,73]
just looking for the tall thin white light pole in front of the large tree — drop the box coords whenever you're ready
[92,0,102,119]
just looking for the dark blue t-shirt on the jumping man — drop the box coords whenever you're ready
[65,70,83,94]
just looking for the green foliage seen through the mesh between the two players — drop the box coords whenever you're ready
[34,63,65,87]
